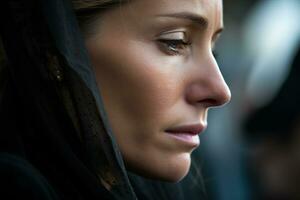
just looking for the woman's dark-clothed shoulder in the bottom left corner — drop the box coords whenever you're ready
[0,153,58,200]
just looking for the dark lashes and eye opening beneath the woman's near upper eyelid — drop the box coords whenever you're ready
[158,39,191,55]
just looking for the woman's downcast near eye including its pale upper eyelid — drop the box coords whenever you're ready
[157,32,191,55]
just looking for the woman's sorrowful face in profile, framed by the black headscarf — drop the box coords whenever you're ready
[86,0,230,181]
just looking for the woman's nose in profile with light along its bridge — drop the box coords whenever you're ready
[186,56,231,107]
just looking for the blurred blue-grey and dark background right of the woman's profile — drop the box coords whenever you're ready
[197,0,300,200]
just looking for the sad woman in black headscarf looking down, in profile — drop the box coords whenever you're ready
[0,0,230,199]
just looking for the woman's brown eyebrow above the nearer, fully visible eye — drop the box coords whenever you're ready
[157,12,208,29]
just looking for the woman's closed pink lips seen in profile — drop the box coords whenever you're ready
[165,124,206,147]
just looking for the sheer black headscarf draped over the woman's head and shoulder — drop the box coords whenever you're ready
[0,0,206,200]
